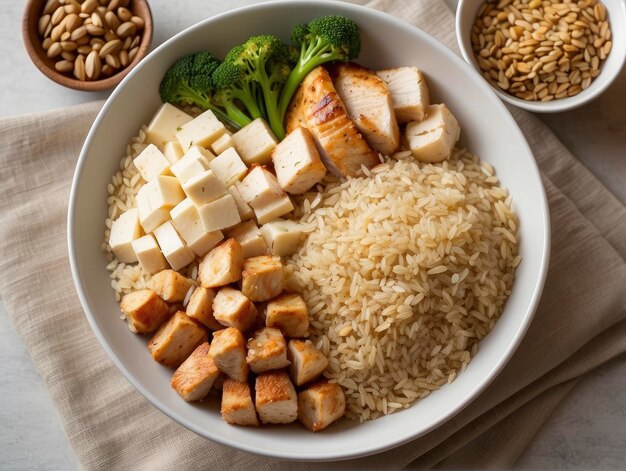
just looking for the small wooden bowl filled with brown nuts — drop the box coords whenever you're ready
[22,0,152,91]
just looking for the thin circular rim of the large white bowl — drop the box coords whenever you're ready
[67,0,550,462]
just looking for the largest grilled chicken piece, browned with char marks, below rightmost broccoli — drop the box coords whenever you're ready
[287,66,380,177]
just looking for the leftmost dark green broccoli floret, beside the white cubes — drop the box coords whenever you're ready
[159,51,251,128]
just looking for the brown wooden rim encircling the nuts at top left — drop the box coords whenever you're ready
[22,0,154,92]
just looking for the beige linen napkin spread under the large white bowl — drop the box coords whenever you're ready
[0,0,626,470]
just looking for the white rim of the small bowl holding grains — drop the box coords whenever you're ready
[454,0,626,113]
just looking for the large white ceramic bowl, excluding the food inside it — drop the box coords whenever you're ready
[68,1,550,460]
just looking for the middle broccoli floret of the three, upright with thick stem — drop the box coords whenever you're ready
[224,35,291,139]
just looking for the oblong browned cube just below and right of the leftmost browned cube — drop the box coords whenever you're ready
[148,311,207,368]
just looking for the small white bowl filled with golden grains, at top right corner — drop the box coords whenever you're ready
[456,0,626,113]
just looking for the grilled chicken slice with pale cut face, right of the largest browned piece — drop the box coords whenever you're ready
[330,63,400,155]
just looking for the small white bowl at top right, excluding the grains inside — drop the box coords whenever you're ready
[456,0,626,113]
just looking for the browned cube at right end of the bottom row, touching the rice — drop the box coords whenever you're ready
[298,381,346,432]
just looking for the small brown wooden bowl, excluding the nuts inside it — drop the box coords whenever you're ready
[22,0,153,92]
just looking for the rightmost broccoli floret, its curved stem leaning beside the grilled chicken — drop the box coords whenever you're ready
[279,15,361,120]
